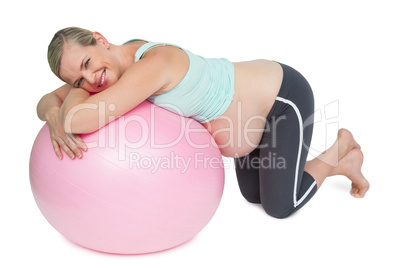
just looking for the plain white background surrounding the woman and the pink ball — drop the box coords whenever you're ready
[0,0,402,267]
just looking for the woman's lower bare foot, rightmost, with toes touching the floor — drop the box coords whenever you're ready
[337,149,370,198]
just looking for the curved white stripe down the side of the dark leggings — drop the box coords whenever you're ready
[276,97,316,207]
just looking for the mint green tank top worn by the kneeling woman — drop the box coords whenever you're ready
[129,39,234,123]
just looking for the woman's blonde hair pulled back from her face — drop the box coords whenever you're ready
[47,27,96,79]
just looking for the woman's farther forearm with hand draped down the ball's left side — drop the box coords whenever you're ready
[36,84,87,159]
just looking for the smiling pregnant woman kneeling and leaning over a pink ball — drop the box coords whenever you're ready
[38,28,369,218]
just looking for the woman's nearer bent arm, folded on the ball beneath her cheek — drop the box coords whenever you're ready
[60,50,174,133]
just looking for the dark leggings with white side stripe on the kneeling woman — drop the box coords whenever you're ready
[235,64,317,218]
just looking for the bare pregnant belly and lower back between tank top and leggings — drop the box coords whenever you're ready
[203,60,283,157]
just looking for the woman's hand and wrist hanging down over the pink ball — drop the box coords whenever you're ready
[46,107,87,159]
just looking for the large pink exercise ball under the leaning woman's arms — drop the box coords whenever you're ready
[29,101,224,254]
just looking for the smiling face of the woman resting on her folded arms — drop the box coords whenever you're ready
[60,34,122,92]
